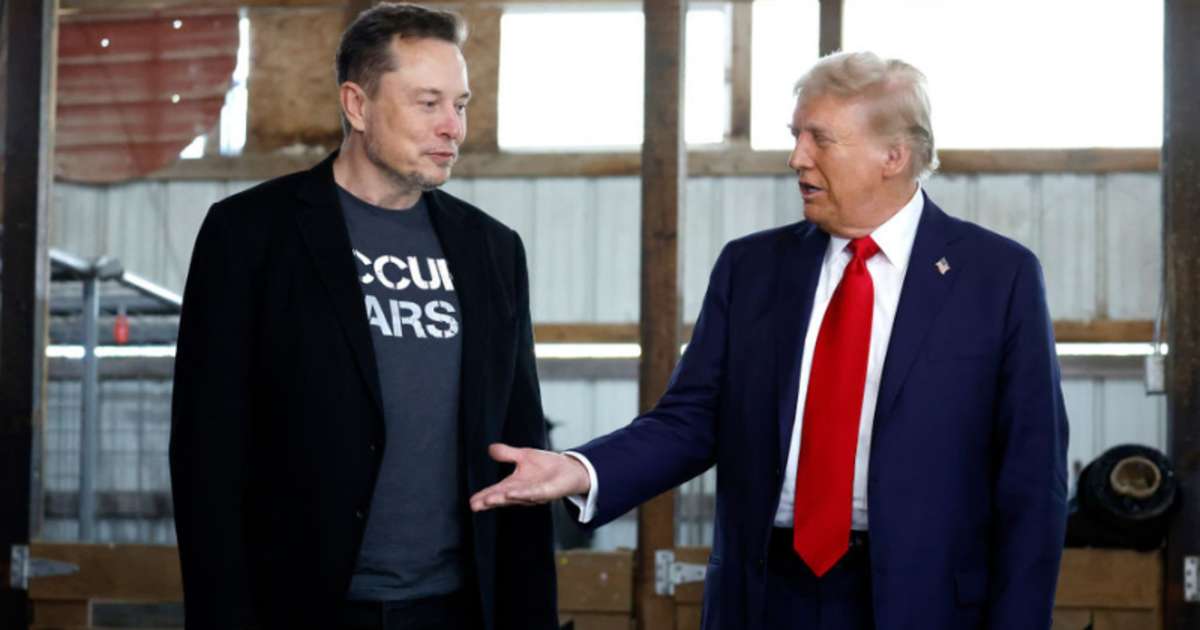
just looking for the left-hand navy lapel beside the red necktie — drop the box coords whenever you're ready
[772,223,829,462]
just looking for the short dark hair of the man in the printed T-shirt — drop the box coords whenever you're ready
[335,2,467,131]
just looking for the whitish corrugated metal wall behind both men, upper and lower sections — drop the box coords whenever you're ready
[47,174,1165,548]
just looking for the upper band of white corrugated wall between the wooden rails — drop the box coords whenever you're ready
[49,174,1162,322]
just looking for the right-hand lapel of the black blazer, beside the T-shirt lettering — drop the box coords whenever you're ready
[425,191,500,468]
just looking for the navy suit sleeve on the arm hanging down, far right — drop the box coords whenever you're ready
[988,254,1068,630]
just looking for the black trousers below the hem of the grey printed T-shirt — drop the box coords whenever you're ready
[340,590,484,630]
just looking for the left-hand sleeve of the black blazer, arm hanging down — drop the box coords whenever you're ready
[169,204,254,630]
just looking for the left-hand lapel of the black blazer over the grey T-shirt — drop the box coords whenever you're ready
[296,152,383,416]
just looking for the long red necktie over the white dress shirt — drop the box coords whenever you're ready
[792,236,880,577]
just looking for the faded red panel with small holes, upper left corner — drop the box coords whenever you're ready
[55,11,239,182]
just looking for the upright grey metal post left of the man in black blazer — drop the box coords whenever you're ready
[79,275,100,542]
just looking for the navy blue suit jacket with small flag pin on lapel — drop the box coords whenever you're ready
[576,197,1067,630]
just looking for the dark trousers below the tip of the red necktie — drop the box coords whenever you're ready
[766,529,875,630]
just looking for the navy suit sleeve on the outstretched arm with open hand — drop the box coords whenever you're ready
[571,245,733,528]
